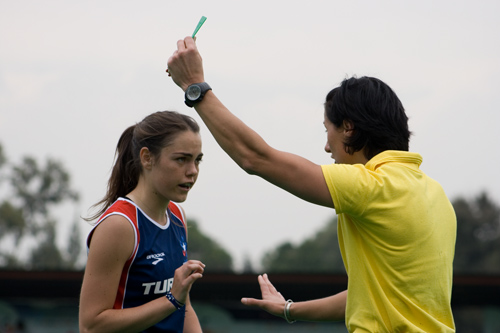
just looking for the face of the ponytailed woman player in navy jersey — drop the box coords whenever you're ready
[147,130,203,202]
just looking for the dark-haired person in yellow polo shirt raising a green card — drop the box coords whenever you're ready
[167,37,456,332]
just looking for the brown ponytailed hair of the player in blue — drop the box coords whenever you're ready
[85,111,200,221]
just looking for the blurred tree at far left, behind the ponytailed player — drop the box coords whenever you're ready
[0,145,82,269]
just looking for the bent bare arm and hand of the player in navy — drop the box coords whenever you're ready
[79,215,204,332]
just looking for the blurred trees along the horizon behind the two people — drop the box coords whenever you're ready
[0,144,500,275]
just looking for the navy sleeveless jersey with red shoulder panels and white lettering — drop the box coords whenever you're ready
[87,198,187,333]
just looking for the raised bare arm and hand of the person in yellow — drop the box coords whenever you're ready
[167,37,333,207]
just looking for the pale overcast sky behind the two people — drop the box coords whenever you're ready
[0,0,500,270]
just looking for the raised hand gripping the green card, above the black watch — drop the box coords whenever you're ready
[167,37,205,91]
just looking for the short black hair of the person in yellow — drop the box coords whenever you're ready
[325,76,411,159]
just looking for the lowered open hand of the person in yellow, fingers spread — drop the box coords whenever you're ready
[241,274,286,318]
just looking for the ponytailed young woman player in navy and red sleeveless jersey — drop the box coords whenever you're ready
[79,111,205,333]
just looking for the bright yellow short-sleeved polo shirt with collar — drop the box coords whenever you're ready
[322,151,456,332]
